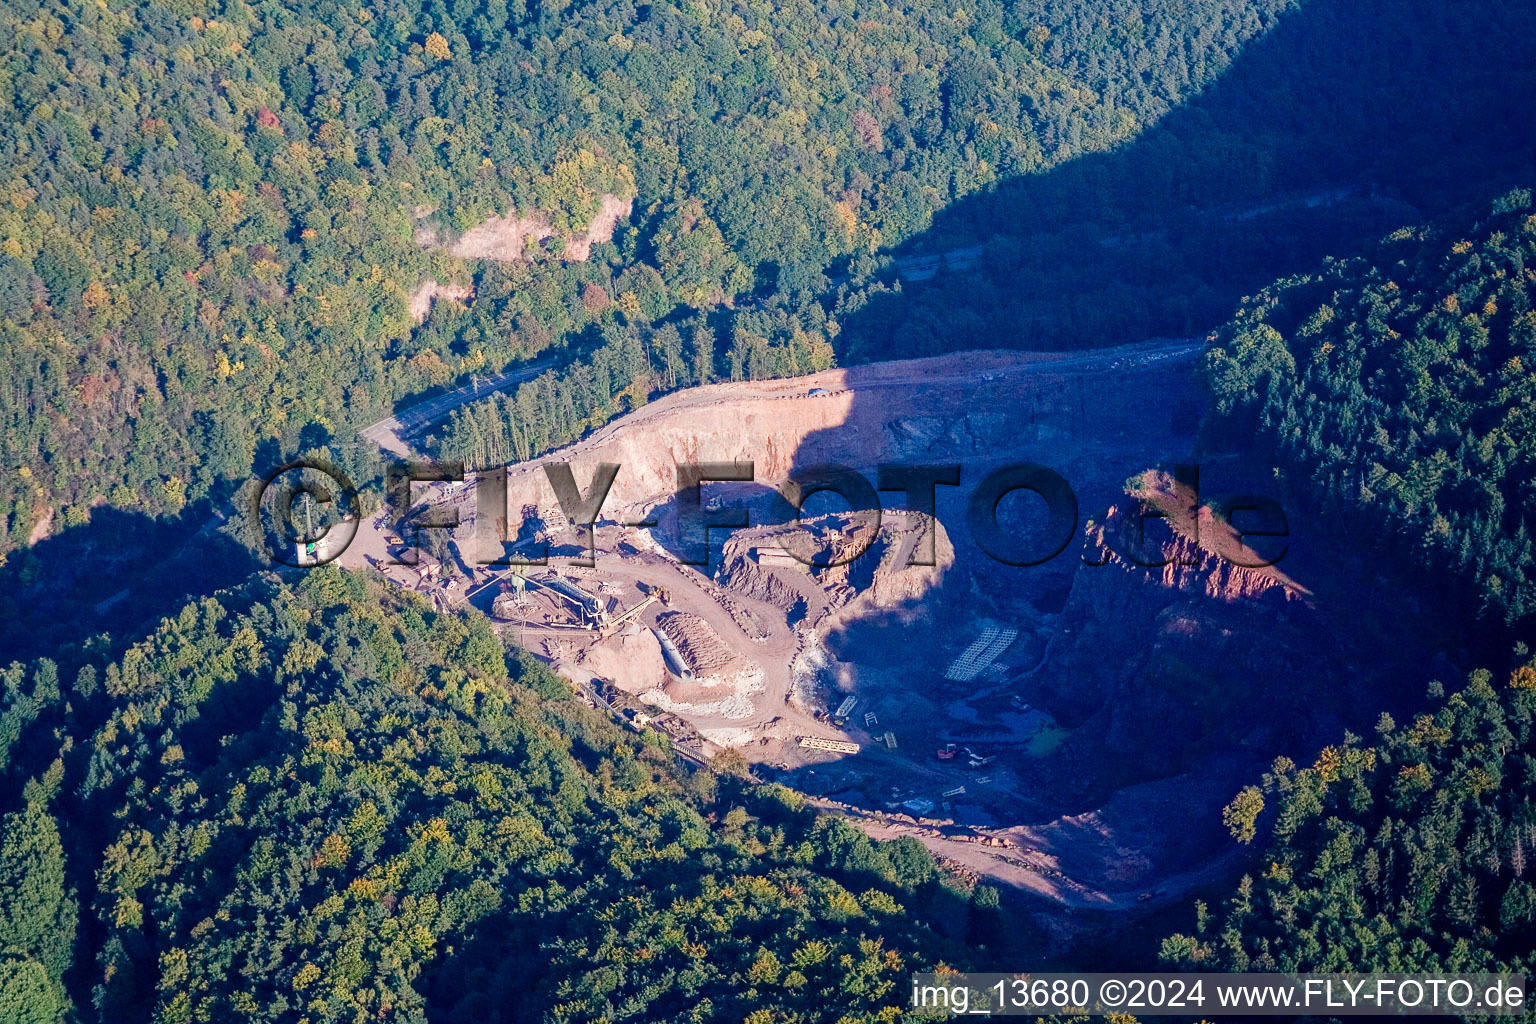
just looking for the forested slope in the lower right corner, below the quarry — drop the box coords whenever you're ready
[1163,665,1536,973]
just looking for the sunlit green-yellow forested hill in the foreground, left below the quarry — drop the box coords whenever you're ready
[0,568,995,1024]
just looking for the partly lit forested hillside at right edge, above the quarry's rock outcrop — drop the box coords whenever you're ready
[1204,190,1536,622]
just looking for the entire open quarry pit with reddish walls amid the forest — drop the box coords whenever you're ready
[341,339,1370,927]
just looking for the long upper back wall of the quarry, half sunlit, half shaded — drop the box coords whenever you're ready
[488,344,1198,534]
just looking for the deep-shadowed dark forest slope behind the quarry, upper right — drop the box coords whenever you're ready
[840,0,1536,362]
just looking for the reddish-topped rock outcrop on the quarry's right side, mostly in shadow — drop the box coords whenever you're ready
[1031,505,1332,791]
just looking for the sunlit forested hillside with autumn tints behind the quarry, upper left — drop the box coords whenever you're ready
[0,0,1289,545]
